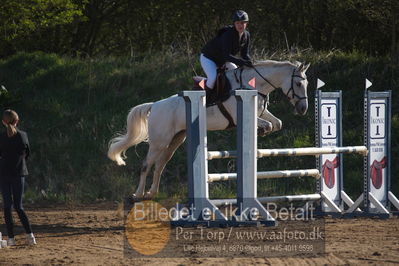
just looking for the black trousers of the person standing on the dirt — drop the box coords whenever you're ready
[0,177,32,238]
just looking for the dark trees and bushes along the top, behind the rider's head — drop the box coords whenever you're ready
[0,0,399,61]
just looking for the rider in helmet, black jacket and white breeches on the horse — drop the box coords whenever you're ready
[200,10,252,90]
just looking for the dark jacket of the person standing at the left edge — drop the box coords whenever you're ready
[0,129,30,178]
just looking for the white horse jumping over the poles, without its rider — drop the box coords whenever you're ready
[108,60,309,198]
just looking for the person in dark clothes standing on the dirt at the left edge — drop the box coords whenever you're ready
[0,109,36,246]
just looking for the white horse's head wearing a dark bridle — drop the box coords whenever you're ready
[281,62,310,115]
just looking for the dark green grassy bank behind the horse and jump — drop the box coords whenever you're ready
[0,50,399,202]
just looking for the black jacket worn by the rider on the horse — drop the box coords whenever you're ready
[201,25,251,67]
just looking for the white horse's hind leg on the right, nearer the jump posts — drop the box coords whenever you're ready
[146,130,186,198]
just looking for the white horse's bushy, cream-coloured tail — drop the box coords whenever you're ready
[108,103,153,165]
